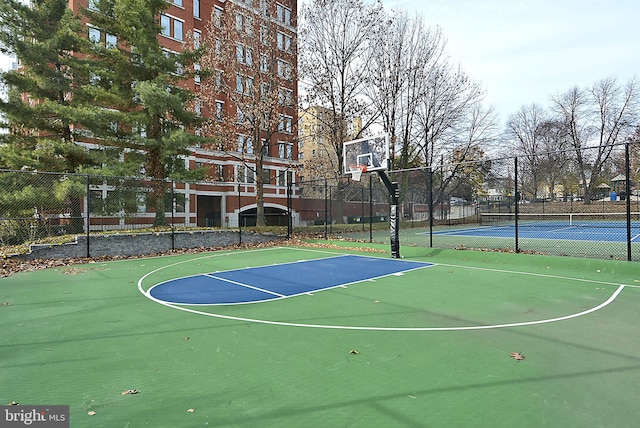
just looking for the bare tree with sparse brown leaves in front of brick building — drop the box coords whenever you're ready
[201,1,297,226]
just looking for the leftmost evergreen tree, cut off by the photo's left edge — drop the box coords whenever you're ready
[0,0,95,172]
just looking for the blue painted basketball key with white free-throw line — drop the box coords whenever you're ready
[149,255,432,305]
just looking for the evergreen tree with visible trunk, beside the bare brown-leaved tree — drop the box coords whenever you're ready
[83,0,203,225]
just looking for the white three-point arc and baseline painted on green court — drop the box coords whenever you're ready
[138,247,640,331]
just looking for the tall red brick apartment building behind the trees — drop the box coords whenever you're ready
[69,0,298,227]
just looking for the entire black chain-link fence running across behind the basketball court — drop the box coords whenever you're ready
[0,143,640,260]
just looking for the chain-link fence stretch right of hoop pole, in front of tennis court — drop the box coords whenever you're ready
[336,143,640,260]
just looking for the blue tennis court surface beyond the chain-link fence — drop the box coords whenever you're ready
[427,224,640,242]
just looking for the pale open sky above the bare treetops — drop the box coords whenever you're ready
[383,0,640,122]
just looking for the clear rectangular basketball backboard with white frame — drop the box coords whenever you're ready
[342,134,389,174]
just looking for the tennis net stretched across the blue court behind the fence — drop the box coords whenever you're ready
[480,212,640,229]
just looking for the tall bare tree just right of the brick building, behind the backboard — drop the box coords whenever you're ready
[298,0,382,219]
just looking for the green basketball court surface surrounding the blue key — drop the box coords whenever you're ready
[0,242,640,428]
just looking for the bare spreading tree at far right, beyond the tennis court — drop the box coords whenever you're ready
[552,78,638,204]
